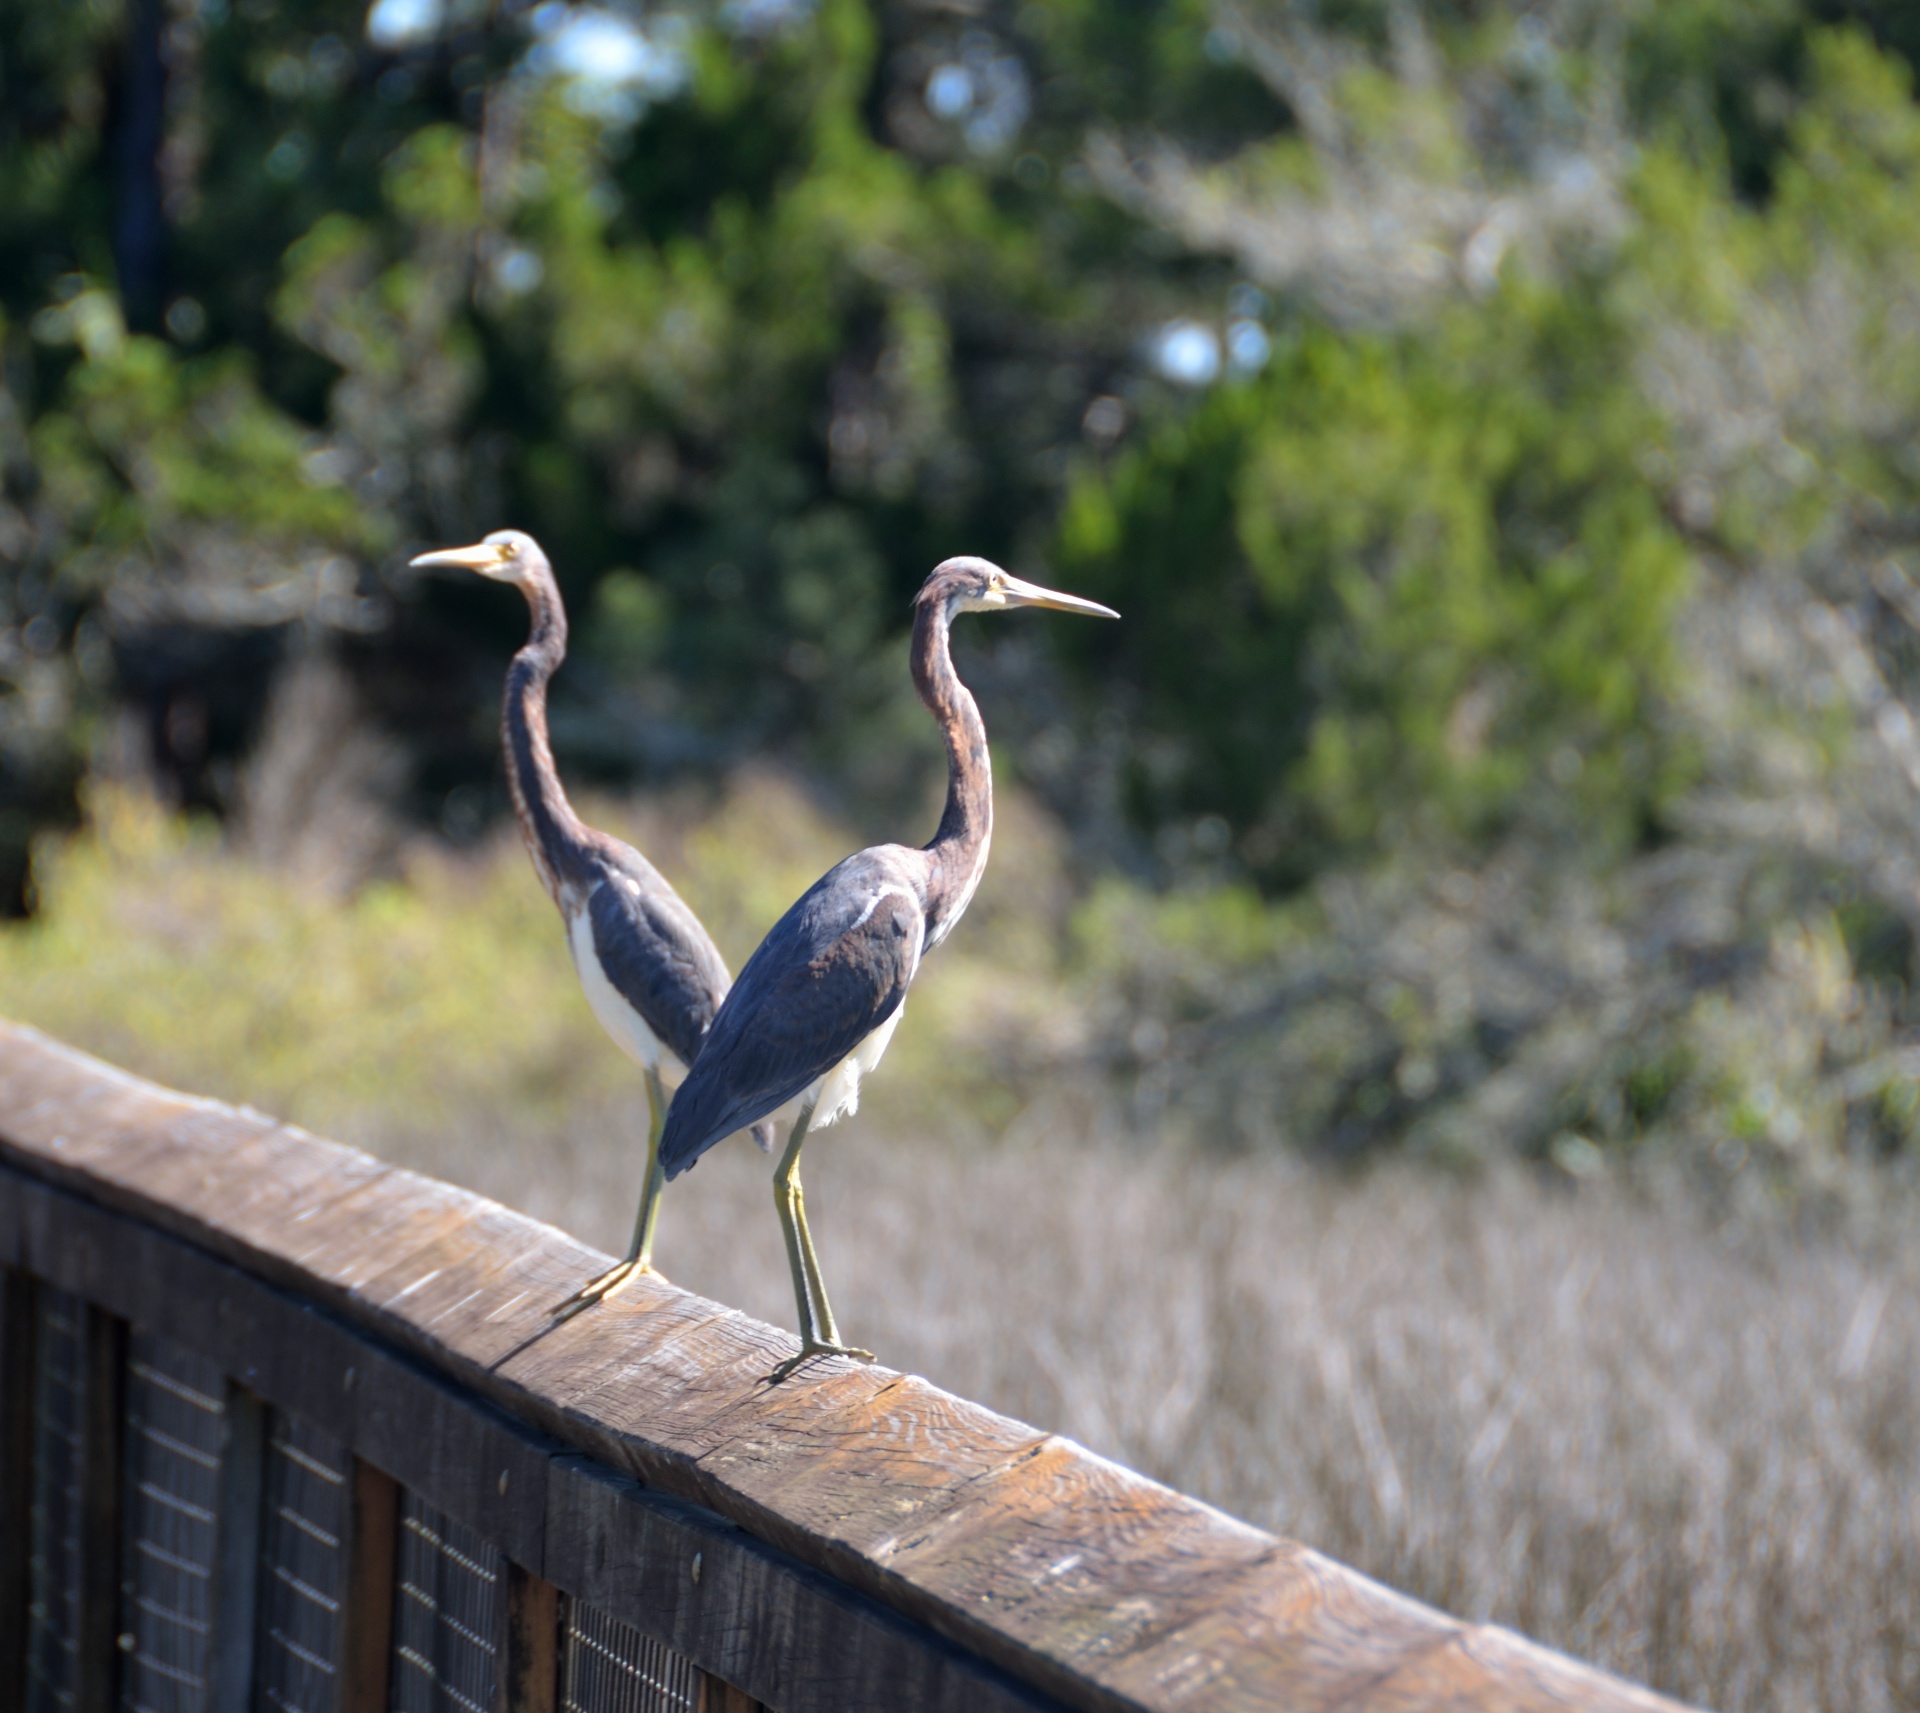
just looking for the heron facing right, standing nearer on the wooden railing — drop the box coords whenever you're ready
[660,557,1119,1383]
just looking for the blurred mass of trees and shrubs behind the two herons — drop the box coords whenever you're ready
[0,0,1920,1182]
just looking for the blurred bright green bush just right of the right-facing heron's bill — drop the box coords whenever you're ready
[1060,277,1686,876]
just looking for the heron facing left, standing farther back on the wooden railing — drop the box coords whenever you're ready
[413,530,772,1314]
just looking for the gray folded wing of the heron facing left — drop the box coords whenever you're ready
[588,872,728,1064]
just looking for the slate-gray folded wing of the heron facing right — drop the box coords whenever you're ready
[660,853,925,1177]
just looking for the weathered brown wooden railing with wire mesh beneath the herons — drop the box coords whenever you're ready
[0,1024,1697,1713]
